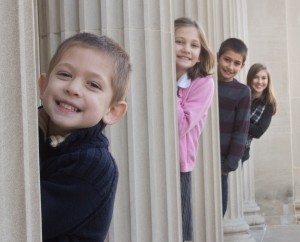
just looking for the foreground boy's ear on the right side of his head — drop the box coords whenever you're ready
[102,101,127,124]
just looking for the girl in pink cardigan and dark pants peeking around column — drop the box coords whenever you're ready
[175,18,214,241]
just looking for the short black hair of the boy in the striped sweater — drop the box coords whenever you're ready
[218,38,248,63]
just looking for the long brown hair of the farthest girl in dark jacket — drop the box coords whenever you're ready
[247,63,277,115]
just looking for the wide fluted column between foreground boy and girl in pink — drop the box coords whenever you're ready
[104,0,182,242]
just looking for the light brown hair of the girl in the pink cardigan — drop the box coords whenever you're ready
[174,17,215,79]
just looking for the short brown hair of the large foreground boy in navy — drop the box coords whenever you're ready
[47,33,131,104]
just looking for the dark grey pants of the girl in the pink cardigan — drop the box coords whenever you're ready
[180,172,193,241]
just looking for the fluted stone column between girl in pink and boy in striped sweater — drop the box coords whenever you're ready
[174,0,223,242]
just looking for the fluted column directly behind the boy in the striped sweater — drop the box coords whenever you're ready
[217,0,255,242]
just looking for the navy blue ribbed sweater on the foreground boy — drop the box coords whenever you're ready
[39,110,118,242]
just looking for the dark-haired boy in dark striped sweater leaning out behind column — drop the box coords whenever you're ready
[217,38,251,216]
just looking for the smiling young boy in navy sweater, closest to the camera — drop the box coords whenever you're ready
[39,33,131,242]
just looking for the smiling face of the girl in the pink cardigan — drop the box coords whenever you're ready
[175,27,201,80]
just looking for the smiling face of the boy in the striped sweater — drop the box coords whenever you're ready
[218,50,244,82]
